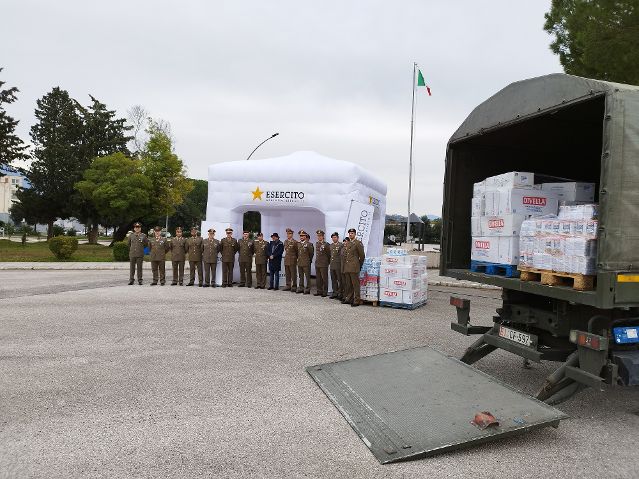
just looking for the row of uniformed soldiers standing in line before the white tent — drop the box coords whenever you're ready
[128,223,364,306]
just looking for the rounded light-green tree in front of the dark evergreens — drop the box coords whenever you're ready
[75,153,153,230]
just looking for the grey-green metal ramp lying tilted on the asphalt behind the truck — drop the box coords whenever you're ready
[306,347,568,464]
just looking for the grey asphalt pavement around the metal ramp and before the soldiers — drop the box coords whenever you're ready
[0,271,639,479]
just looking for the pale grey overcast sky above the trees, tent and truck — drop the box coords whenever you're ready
[0,0,561,214]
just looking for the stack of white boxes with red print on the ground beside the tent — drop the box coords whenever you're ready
[379,248,428,309]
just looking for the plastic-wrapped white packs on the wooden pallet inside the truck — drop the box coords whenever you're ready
[519,204,599,275]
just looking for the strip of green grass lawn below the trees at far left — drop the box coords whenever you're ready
[0,240,113,262]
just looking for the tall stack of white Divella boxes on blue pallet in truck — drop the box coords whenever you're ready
[471,171,558,265]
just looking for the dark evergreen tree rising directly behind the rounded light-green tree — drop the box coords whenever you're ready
[72,95,133,244]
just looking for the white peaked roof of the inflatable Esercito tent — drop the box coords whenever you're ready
[209,151,386,195]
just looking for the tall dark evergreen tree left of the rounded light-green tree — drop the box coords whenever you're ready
[26,87,85,239]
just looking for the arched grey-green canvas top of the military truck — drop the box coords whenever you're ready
[449,73,639,143]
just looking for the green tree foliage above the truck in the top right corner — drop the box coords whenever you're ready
[544,0,639,84]
